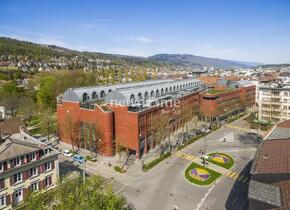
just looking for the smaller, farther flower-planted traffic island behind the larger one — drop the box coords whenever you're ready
[207,152,234,169]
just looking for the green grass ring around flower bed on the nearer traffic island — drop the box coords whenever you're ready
[184,163,221,185]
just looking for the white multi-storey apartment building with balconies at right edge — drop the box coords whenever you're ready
[257,84,290,122]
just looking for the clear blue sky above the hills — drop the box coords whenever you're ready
[0,0,290,64]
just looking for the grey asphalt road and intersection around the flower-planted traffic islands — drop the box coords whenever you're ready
[60,116,257,210]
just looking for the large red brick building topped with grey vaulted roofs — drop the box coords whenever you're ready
[57,78,203,158]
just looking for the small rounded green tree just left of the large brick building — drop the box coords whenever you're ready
[39,109,57,140]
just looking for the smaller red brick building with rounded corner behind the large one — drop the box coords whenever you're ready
[200,81,256,121]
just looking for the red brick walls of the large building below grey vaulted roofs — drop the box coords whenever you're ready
[57,92,199,158]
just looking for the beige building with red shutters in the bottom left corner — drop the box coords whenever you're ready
[0,132,59,210]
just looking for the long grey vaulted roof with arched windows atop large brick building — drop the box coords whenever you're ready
[62,78,202,104]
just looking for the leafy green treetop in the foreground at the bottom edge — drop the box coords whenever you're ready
[20,176,134,210]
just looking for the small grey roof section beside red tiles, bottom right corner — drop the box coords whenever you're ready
[248,180,282,207]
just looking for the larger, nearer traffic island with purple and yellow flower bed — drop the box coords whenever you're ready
[185,163,221,185]
